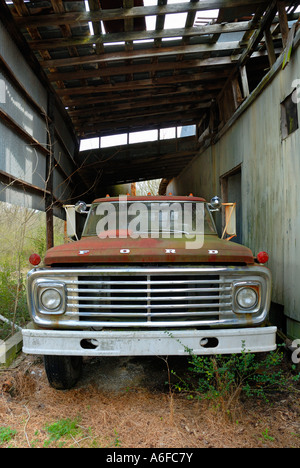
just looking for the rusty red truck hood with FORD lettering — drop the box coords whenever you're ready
[44,235,254,266]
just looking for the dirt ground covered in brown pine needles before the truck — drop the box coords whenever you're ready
[0,355,300,449]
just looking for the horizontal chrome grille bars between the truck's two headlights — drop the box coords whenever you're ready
[65,269,232,327]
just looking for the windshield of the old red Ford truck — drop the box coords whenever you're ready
[82,200,217,238]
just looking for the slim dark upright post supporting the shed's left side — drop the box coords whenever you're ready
[45,93,55,249]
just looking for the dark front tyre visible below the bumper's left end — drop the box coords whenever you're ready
[44,356,82,390]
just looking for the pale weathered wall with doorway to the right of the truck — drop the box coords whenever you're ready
[167,37,300,338]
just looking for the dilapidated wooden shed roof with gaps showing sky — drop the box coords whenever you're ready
[0,0,299,189]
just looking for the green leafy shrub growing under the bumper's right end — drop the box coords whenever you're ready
[170,345,300,416]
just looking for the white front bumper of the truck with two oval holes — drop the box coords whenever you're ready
[23,327,277,356]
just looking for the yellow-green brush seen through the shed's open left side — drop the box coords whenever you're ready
[0,203,64,340]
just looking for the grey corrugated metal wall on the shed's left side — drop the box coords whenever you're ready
[0,17,78,216]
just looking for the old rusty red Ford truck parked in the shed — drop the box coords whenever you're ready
[23,196,276,389]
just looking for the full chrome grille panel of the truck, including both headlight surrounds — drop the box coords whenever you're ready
[27,265,271,330]
